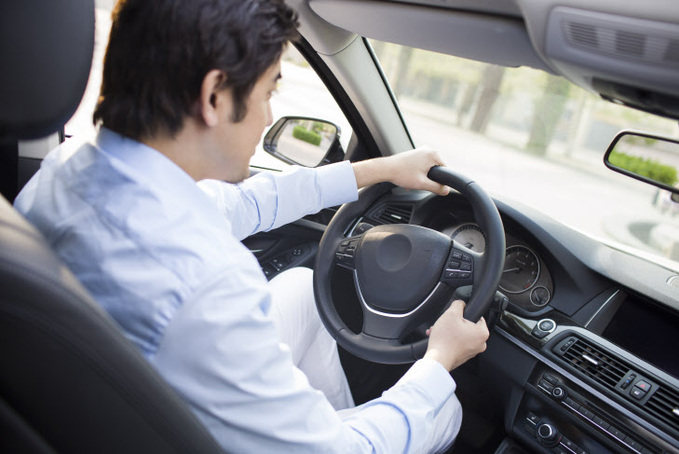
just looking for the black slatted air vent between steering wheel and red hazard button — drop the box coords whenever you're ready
[557,337,629,389]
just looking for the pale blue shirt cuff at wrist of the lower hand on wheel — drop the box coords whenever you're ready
[396,358,457,413]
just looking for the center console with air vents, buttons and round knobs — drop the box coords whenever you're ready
[498,311,679,454]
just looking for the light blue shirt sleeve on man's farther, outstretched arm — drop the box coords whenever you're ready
[198,161,358,240]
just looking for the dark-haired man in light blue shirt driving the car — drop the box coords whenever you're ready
[16,0,488,452]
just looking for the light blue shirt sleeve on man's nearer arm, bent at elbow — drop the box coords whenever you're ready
[152,266,455,453]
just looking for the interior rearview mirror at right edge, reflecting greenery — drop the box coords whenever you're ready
[604,131,679,194]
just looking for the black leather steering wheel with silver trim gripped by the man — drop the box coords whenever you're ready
[313,167,505,364]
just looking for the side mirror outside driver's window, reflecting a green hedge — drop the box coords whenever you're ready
[263,117,344,167]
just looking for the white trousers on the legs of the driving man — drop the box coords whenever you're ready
[269,268,462,453]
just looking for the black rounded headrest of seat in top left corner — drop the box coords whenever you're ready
[0,0,94,139]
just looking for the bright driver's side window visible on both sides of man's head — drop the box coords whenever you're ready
[64,6,352,170]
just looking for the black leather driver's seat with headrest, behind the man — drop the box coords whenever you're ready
[0,0,221,453]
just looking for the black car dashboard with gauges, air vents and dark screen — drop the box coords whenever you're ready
[349,190,679,454]
